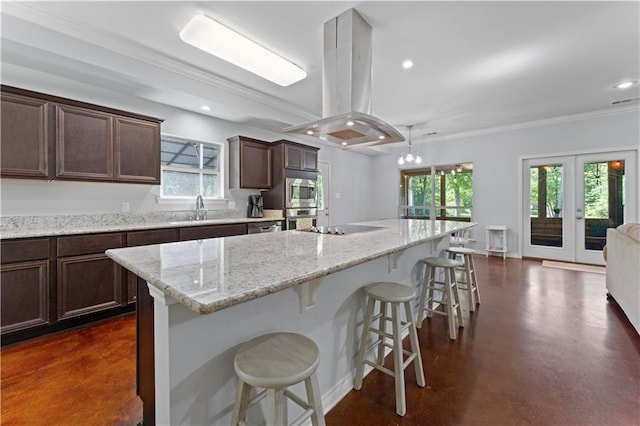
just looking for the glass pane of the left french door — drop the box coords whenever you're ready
[529,164,564,247]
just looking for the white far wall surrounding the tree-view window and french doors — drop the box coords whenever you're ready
[374,111,640,256]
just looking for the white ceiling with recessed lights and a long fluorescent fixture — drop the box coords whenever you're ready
[2,1,640,148]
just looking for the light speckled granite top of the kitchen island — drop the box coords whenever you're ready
[106,219,476,314]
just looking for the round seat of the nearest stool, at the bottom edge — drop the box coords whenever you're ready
[233,333,320,388]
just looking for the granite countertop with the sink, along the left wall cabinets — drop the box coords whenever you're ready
[0,210,284,240]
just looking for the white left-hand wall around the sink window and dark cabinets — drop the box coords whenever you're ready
[0,75,374,223]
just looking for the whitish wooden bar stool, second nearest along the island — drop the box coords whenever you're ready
[354,282,425,416]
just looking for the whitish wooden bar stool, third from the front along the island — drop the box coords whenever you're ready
[418,257,464,340]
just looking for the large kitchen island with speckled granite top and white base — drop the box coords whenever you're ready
[106,219,475,425]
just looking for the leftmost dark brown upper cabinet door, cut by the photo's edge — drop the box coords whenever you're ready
[0,93,50,179]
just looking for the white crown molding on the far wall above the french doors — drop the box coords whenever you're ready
[413,105,640,144]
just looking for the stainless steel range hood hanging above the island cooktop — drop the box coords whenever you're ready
[284,9,404,148]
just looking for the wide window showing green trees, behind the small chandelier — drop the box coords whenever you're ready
[400,163,473,221]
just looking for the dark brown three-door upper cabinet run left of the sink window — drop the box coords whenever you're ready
[1,86,162,184]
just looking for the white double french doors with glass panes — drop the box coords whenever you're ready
[522,151,638,265]
